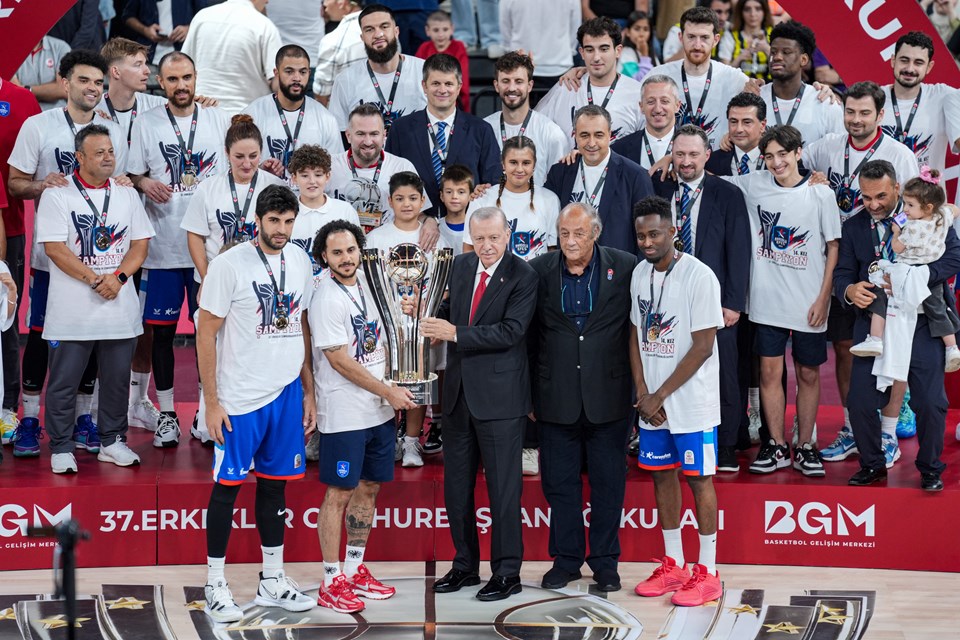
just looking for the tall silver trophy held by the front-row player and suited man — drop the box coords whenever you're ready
[361,243,453,405]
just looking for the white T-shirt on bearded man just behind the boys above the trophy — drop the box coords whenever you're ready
[325,151,433,229]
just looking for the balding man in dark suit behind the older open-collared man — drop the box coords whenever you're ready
[544,104,653,255]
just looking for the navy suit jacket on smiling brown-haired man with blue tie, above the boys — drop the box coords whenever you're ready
[384,109,503,217]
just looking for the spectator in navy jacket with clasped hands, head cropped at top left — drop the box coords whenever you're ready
[121,0,201,64]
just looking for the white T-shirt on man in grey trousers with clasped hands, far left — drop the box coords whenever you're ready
[36,176,153,340]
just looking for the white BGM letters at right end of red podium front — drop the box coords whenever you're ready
[763,500,876,538]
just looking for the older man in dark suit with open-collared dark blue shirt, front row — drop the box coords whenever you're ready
[530,202,637,591]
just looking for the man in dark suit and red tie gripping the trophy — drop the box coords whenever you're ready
[420,206,537,601]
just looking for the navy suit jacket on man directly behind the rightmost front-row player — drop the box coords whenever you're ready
[653,173,750,311]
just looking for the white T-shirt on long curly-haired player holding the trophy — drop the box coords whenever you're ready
[310,270,393,433]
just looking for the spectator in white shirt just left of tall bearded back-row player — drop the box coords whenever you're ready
[313,0,367,107]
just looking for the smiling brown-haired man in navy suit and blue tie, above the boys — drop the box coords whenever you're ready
[384,53,503,218]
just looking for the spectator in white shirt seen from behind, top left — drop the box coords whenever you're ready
[183,0,282,115]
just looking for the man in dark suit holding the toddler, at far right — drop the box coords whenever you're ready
[833,160,960,491]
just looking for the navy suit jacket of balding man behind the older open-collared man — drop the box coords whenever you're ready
[544,152,653,255]
